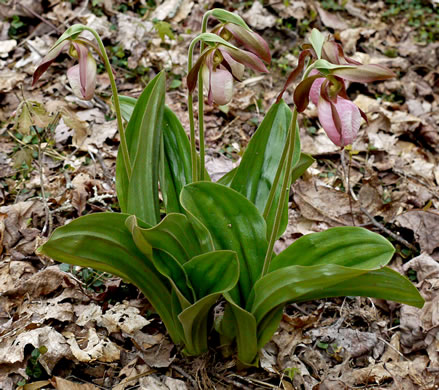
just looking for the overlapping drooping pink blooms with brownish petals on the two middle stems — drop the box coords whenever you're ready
[187,23,271,105]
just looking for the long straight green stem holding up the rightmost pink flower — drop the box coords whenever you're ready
[262,107,297,276]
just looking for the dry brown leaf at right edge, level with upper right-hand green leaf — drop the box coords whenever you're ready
[395,210,439,254]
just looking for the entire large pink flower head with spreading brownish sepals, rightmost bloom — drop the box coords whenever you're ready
[278,30,395,146]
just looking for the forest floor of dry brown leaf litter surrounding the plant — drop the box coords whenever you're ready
[0,0,439,390]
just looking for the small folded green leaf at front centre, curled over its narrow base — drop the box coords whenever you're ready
[178,251,239,355]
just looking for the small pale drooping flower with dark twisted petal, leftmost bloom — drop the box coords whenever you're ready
[32,38,96,100]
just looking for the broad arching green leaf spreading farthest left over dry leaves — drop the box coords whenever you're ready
[38,213,181,344]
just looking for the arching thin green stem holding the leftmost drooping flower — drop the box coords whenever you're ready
[84,26,131,177]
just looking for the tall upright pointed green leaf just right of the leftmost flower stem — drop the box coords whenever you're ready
[126,72,166,225]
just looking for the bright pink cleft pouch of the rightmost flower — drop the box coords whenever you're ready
[317,97,361,146]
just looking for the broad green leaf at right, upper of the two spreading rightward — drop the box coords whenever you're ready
[268,226,395,272]
